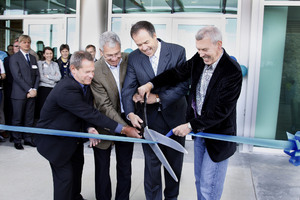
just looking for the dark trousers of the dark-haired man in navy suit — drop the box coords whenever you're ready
[142,112,185,200]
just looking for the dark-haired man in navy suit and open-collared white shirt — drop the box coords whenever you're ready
[122,21,188,199]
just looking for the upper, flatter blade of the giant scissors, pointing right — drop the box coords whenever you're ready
[147,127,188,154]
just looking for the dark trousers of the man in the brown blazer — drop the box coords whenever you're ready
[93,142,133,200]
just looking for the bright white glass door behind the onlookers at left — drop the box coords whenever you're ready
[23,19,66,59]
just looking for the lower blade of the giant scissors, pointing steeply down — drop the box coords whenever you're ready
[144,126,178,182]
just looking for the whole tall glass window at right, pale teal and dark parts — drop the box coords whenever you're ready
[255,6,300,140]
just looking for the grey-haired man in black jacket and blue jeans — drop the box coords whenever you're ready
[138,26,242,200]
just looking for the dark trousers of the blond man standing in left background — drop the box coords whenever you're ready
[11,98,35,143]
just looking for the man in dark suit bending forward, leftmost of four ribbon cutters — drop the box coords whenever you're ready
[36,51,140,200]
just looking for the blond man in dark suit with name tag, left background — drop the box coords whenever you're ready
[9,35,40,150]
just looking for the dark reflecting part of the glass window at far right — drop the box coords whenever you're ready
[276,7,300,139]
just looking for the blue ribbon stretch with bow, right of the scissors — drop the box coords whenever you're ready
[166,130,300,166]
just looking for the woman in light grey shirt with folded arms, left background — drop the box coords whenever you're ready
[36,47,61,118]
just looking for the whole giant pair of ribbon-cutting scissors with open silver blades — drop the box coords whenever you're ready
[144,95,188,182]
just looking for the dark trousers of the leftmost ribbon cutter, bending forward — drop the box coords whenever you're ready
[50,142,84,200]
